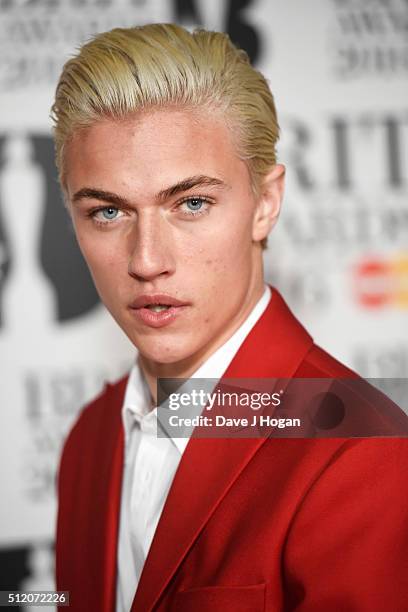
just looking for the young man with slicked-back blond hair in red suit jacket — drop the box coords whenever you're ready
[53,24,408,612]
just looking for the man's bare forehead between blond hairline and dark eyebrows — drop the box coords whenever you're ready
[65,109,249,193]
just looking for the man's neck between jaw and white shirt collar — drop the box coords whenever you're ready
[139,278,264,404]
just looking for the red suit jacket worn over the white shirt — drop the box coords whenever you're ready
[57,290,408,612]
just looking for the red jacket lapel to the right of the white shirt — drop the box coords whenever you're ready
[132,289,313,612]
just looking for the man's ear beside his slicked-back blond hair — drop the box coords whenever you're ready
[252,164,285,242]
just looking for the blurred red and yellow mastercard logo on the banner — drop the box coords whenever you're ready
[353,254,408,309]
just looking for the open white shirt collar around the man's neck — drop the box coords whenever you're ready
[122,285,271,455]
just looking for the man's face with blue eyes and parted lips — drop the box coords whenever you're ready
[65,109,274,364]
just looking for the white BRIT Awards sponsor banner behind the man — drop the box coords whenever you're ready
[0,0,408,604]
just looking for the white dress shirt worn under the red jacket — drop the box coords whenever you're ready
[116,285,271,612]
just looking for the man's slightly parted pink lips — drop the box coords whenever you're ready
[130,293,189,328]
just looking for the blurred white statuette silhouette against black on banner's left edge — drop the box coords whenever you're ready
[0,135,55,338]
